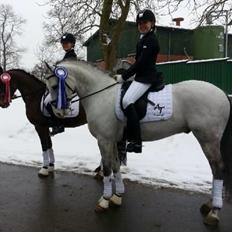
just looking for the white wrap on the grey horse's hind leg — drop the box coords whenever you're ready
[212,180,223,209]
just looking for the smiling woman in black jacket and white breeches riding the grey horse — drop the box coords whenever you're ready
[122,10,160,153]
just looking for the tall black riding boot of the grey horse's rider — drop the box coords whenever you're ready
[125,104,142,153]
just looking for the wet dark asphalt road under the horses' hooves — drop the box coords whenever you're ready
[0,164,232,232]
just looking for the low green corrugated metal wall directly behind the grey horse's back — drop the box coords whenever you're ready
[157,59,232,94]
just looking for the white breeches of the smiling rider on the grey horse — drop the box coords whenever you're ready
[122,81,151,109]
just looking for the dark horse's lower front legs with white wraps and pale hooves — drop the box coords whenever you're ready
[35,125,55,177]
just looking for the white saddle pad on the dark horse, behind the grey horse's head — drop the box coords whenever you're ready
[40,93,80,118]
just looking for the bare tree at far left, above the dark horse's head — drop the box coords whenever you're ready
[0,4,25,70]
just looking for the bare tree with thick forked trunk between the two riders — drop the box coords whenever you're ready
[44,0,156,70]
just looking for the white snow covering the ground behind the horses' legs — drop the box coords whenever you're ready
[0,99,212,192]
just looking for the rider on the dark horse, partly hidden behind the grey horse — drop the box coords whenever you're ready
[47,33,77,136]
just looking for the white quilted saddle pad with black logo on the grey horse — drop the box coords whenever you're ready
[115,84,173,122]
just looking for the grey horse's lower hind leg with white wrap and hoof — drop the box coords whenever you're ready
[199,139,224,226]
